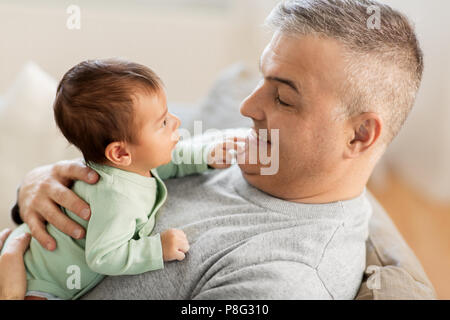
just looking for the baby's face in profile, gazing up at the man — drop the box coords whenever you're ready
[131,90,180,170]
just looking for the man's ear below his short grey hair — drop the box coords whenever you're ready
[344,112,383,158]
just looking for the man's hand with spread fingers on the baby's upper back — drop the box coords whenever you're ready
[18,159,98,251]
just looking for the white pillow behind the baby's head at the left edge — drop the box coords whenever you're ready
[0,62,80,227]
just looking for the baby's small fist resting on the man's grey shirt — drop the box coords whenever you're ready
[161,229,189,261]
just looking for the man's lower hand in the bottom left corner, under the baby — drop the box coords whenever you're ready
[0,229,31,300]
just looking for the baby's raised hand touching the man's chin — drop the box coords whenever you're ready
[208,137,245,169]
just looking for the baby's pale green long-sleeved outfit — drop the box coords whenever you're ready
[3,142,213,299]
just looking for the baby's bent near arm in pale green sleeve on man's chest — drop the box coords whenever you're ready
[85,191,164,275]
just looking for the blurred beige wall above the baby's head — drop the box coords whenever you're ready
[0,0,274,102]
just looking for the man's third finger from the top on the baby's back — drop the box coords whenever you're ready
[42,202,85,239]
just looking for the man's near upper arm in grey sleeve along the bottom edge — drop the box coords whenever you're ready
[192,261,332,300]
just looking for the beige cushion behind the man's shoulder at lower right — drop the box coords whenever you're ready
[356,194,436,300]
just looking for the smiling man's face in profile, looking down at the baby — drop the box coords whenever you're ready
[240,32,348,200]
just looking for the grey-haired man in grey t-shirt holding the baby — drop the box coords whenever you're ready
[12,0,423,299]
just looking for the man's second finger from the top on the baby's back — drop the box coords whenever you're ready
[48,183,91,221]
